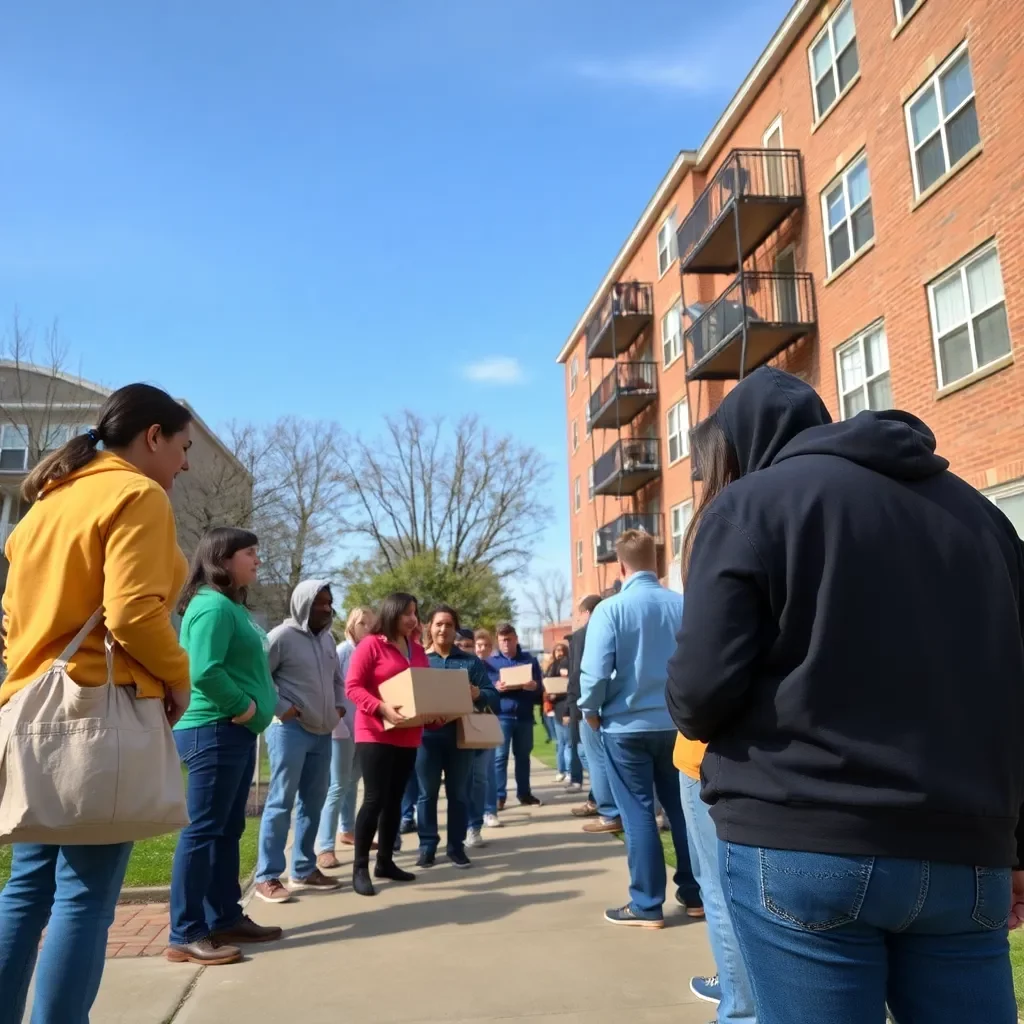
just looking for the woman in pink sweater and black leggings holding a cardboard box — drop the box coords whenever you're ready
[345,593,430,896]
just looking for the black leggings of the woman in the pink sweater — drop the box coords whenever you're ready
[352,743,416,867]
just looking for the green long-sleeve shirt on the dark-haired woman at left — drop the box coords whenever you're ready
[175,587,276,734]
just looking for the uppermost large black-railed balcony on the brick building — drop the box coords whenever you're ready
[676,150,805,273]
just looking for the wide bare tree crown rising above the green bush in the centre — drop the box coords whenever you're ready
[341,411,551,578]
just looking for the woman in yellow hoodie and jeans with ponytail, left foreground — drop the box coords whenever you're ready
[0,384,193,1024]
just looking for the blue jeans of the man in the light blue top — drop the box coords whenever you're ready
[591,730,700,921]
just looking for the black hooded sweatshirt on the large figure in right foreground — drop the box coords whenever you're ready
[668,367,1024,867]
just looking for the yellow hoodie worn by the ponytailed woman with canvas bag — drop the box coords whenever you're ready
[0,452,188,706]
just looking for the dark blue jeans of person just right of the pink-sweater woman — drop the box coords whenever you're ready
[416,722,473,853]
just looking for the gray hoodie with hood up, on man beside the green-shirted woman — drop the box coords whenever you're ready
[267,580,345,735]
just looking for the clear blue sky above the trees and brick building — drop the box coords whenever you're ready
[0,0,788,614]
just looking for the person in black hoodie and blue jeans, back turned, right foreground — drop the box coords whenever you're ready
[668,367,1024,1024]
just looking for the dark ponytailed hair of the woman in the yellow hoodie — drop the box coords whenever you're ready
[22,384,193,502]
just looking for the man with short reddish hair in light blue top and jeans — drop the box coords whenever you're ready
[580,529,701,928]
